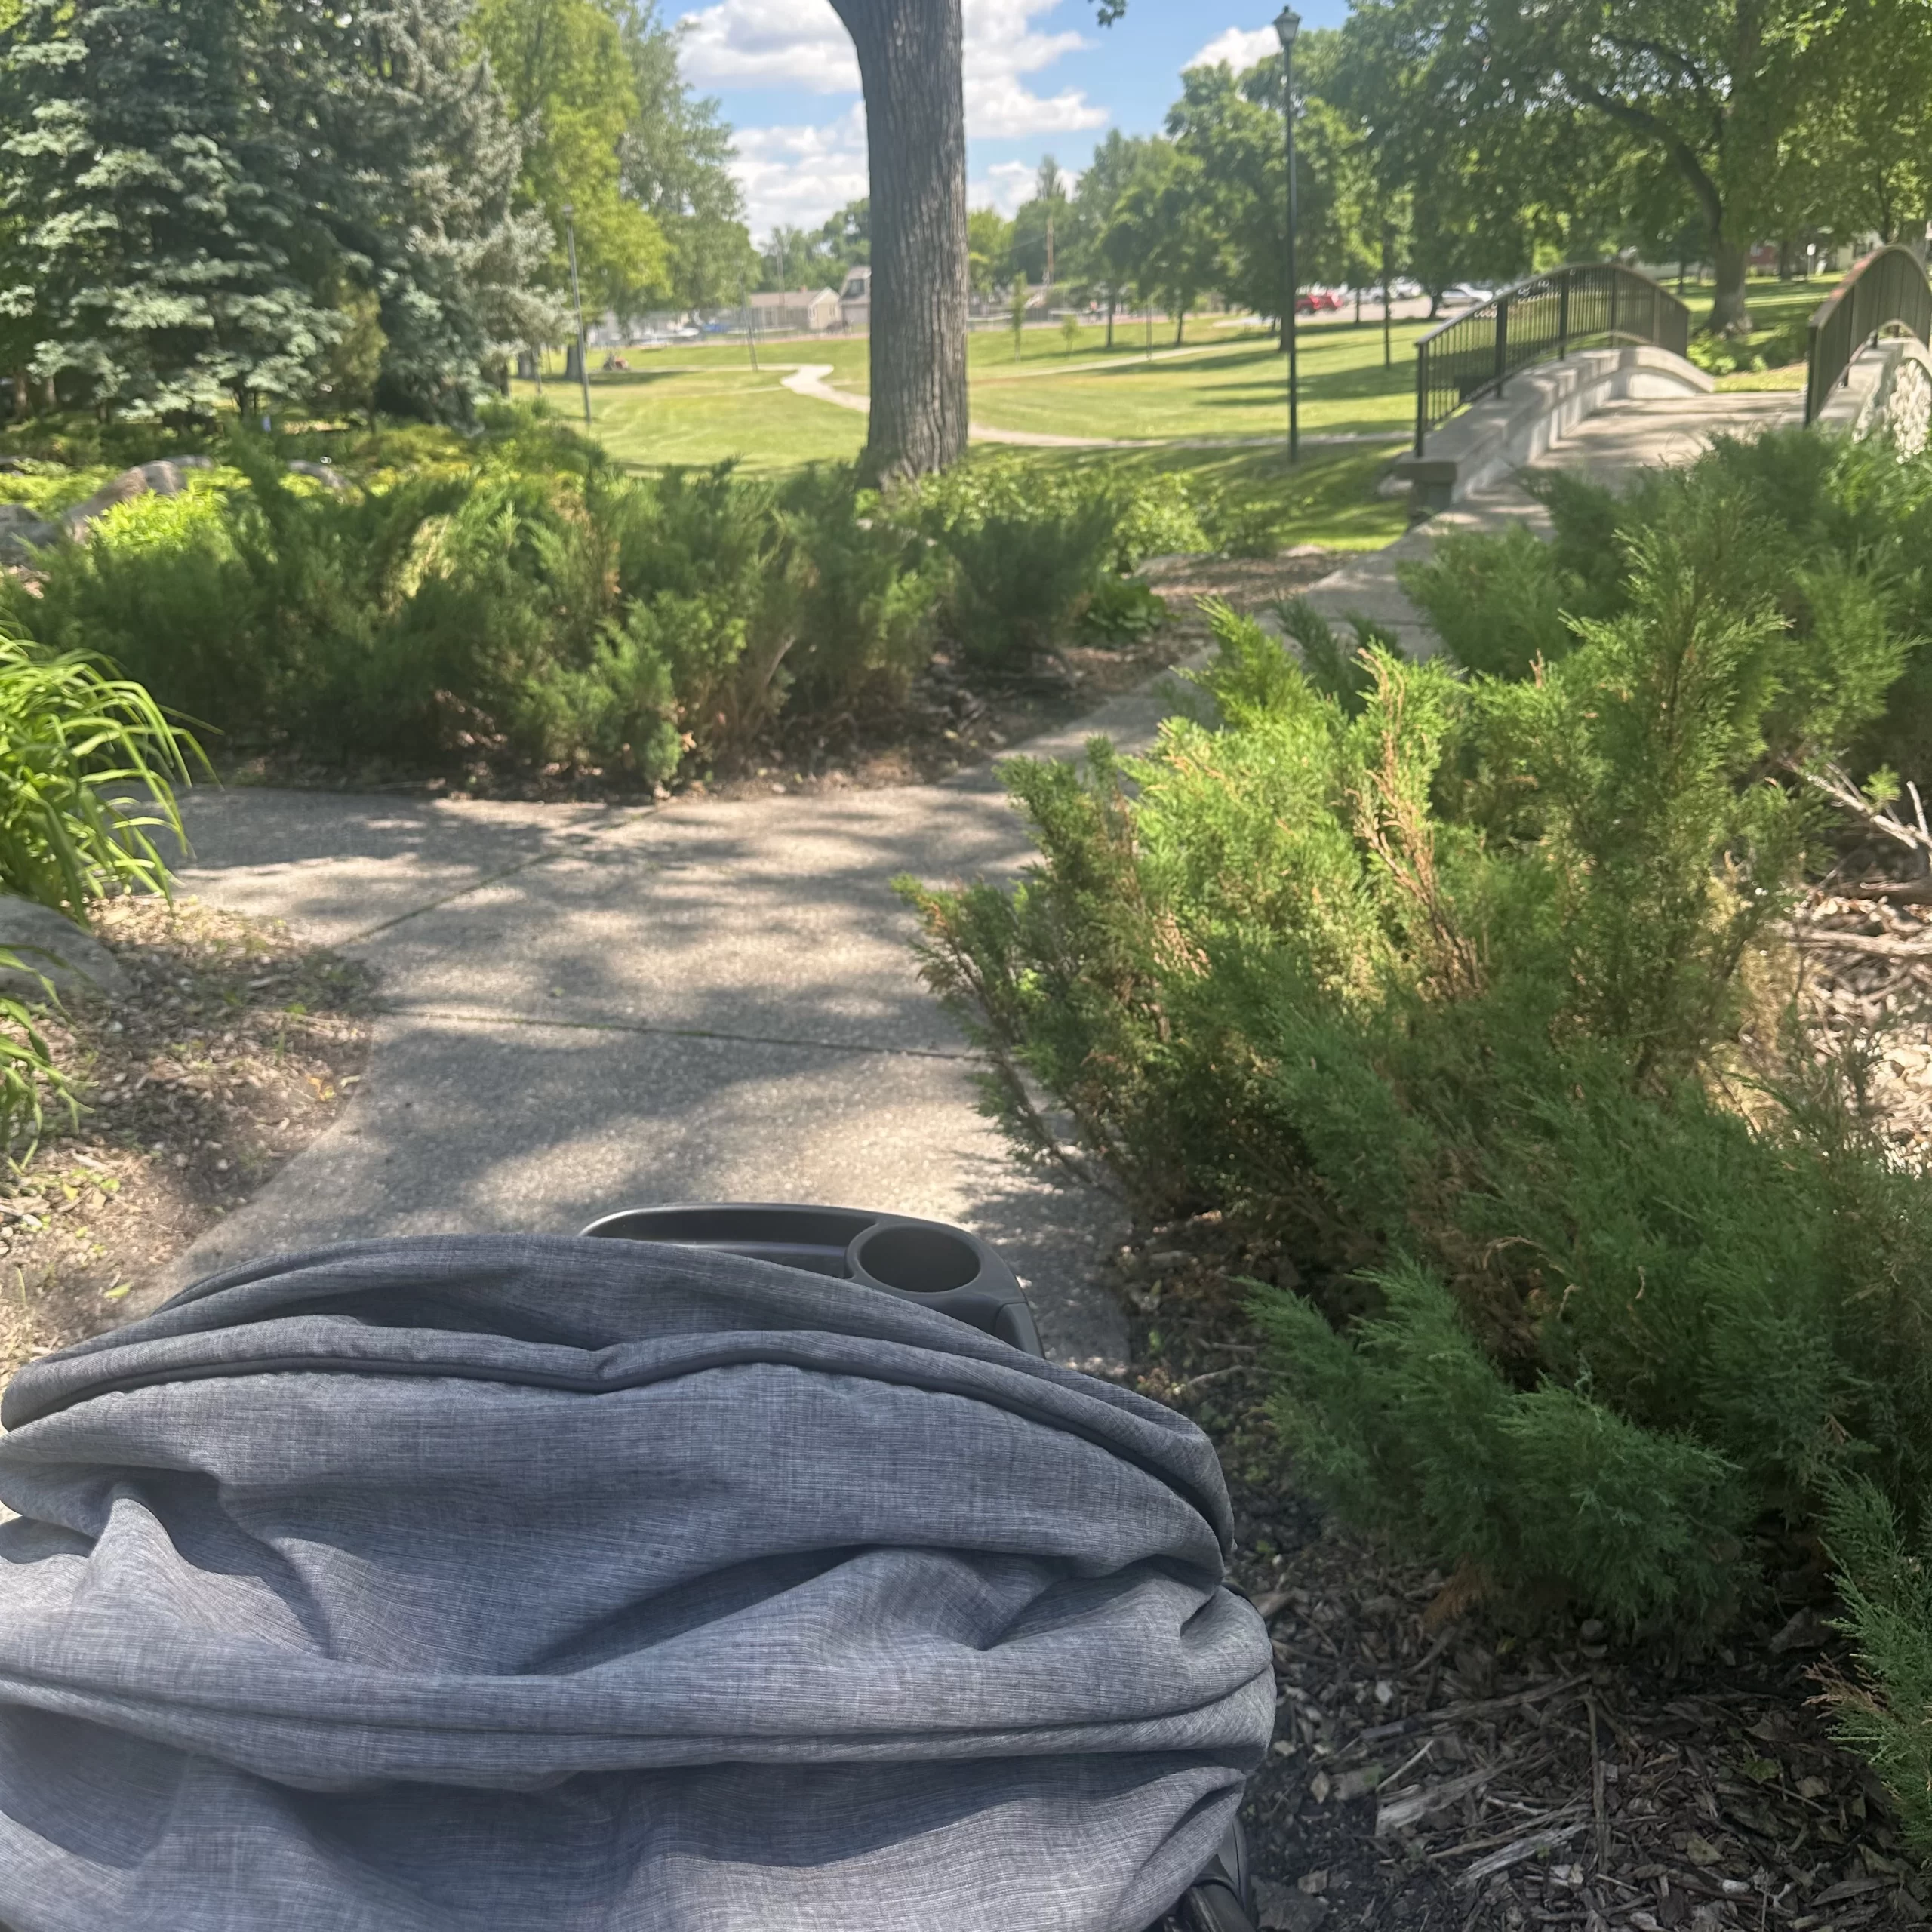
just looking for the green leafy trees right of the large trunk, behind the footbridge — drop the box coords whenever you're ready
[968,0,1932,347]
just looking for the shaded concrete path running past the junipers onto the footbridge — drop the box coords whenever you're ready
[130,380,1791,1367]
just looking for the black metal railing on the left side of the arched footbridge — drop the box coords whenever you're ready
[1416,261,1690,456]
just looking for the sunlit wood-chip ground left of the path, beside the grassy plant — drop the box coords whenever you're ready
[0,898,369,1377]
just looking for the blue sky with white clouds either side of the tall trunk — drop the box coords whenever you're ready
[666,0,1349,238]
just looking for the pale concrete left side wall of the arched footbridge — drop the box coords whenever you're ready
[1395,344,1714,518]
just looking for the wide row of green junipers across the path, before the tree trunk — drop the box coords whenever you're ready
[0,419,1167,780]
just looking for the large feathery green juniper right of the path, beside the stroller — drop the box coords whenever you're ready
[904,450,1932,1632]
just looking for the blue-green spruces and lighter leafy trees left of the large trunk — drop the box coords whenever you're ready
[0,0,755,420]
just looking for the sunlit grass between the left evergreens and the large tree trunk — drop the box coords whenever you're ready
[512,369,866,472]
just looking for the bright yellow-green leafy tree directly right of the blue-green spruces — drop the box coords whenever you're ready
[472,0,670,315]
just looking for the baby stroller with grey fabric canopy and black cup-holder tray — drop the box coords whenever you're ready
[0,1205,1273,1932]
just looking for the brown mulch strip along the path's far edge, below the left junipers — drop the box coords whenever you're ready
[211,545,1337,804]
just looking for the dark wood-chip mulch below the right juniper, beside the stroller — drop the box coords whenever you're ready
[1115,1244,1926,1932]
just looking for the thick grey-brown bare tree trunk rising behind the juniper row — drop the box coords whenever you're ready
[832,0,968,483]
